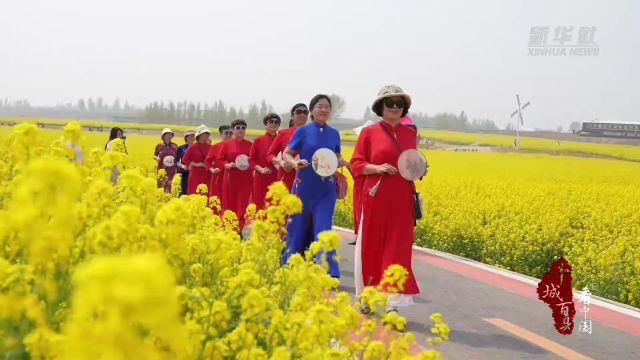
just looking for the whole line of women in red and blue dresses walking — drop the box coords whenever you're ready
[142,85,419,313]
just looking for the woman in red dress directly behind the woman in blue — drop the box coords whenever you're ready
[267,103,309,191]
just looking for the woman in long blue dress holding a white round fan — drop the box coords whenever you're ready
[282,94,347,278]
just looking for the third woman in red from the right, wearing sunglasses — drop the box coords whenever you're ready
[249,113,282,210]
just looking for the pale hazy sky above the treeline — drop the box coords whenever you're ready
[0,0,640,128]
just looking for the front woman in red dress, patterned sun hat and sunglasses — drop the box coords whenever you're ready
[351,85,420,313]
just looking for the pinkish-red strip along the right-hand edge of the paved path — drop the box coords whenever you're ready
[340,231,640,336]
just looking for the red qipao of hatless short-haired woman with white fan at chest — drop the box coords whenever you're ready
[216,139,253,230]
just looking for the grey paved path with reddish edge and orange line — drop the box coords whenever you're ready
[339,231,640,360]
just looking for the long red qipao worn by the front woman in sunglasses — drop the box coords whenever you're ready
[351,121,420,294]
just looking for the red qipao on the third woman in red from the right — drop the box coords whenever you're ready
[249,132,278,210]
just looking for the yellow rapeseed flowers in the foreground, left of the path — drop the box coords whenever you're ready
[0,123,449,359]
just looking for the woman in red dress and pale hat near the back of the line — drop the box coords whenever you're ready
[182,125,211,195]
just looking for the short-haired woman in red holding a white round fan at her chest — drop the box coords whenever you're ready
[216,119,253,233]
